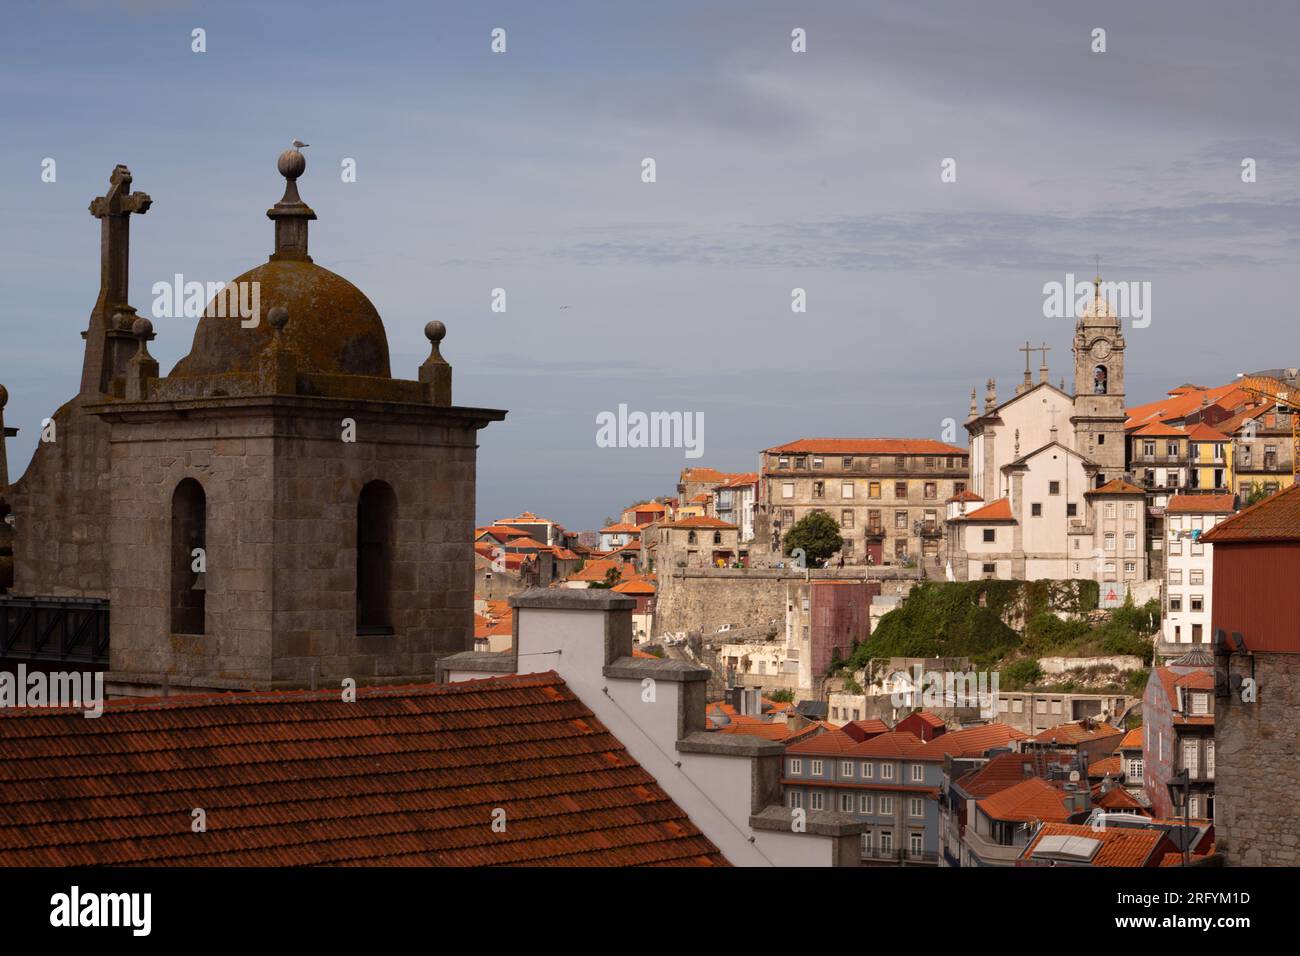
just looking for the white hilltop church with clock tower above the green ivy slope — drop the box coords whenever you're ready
[946,280,1147,581]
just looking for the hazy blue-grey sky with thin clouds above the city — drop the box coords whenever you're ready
[0,0,1300,528]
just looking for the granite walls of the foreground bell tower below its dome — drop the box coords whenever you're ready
[100,399,477,687]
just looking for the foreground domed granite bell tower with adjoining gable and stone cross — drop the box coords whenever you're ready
[1,150,504,693]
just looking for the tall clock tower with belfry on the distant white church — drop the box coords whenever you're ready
[1070,276,1127,485]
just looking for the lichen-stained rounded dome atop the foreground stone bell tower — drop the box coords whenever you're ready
[172,258,391,378]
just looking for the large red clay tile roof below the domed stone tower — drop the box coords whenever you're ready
[0,672,727,866]
